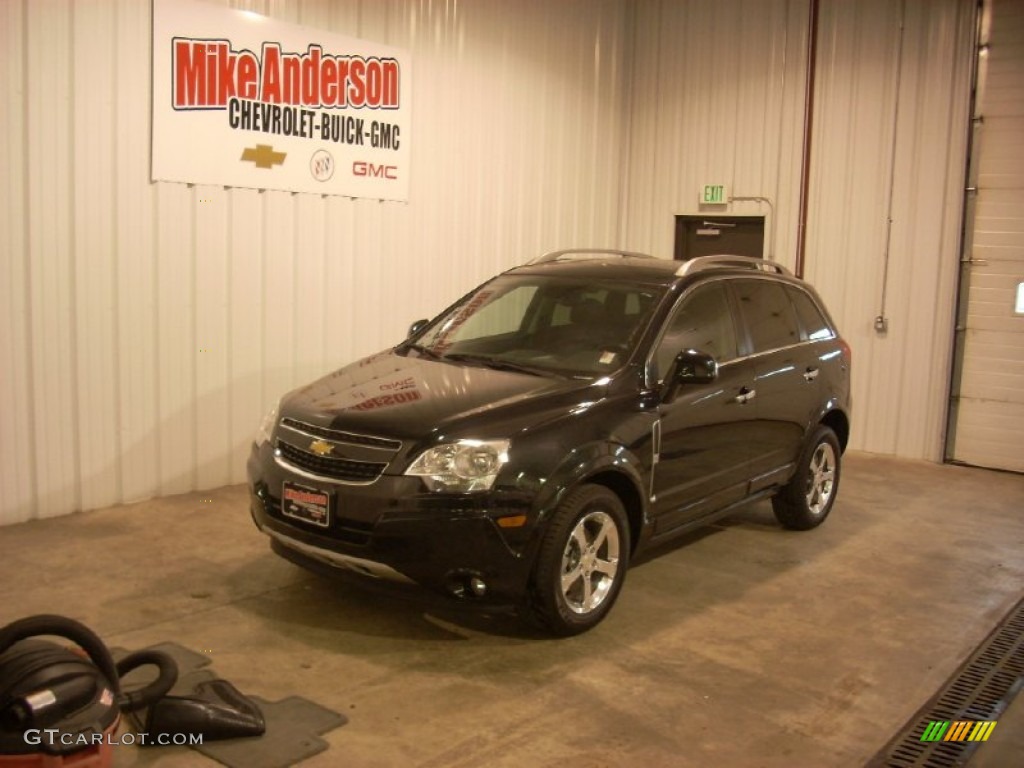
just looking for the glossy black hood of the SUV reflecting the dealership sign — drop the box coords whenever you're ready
[281,350,594,440]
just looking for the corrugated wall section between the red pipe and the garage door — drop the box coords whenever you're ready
[806,0,975,461]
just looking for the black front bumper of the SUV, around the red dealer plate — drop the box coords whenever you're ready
[247,443,535,605]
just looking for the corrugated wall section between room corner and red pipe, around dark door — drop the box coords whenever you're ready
[624,0,808,264]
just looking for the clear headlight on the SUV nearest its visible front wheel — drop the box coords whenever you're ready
[406,440,509,493]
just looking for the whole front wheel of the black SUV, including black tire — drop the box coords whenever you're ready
[531,485,630,637]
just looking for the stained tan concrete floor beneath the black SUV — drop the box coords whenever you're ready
[0,454,1024,768]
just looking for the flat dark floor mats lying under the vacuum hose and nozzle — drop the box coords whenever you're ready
[113,643,348,768]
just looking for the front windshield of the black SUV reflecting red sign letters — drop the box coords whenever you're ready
[410,275,662,376]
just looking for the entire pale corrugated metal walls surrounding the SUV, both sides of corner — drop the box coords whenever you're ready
[0,0,973,522]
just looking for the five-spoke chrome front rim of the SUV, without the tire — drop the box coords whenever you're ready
[561,511,618,614]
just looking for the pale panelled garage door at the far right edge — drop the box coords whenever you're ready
[949,0,1024,472]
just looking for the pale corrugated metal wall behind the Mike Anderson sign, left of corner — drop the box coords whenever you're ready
[0,0,628,523]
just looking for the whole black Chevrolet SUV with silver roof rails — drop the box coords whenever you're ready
[248,250,850,635]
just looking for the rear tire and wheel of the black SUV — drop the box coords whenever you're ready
[772,425,843,530]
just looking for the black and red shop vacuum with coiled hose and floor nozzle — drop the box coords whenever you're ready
[0,615,265,768]
